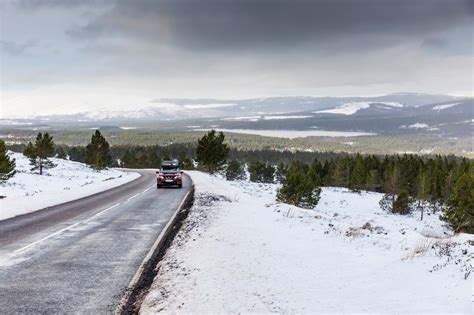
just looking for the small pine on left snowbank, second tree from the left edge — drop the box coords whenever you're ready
[23,132,56,175]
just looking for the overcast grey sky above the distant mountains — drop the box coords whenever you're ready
[0,0,474,117]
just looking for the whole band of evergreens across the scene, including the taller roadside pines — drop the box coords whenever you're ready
[0,130,474,233]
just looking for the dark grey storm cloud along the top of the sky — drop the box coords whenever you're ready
[68,0,474,49]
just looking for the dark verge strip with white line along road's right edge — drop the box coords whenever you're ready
[113,174,194,314]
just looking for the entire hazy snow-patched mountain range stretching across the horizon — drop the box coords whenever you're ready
[0,93,474,137]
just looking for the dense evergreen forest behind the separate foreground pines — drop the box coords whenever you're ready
[25,144,474,209]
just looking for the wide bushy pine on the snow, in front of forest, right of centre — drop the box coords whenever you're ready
[277,162,321,209]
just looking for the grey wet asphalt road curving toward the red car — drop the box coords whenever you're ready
[0,171,191,314]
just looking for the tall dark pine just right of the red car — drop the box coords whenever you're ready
[196,130,230,174]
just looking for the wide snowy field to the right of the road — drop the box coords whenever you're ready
[141,172,474,314]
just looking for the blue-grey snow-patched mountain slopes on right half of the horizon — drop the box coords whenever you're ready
[212,99,474,137]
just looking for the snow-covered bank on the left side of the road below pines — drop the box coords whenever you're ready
[0,153,139,220]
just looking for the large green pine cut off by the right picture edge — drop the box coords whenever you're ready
[441,173,474,233]
